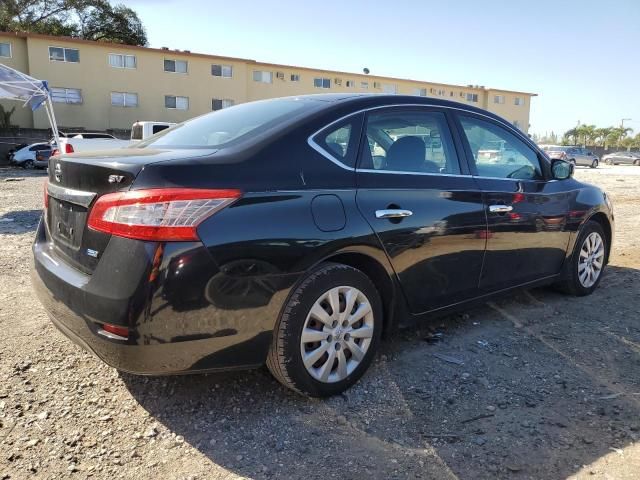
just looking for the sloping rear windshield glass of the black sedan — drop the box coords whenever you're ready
[137,98,309,148]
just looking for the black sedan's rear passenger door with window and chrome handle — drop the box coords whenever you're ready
[357,107,486,313]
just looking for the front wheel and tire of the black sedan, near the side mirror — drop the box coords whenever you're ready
[557,221,608,297]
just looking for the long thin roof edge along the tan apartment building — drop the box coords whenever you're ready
[0,32,538,97]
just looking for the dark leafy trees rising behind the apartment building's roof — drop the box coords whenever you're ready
[0,0,147,45]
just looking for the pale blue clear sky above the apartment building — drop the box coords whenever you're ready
[124,0,640,133]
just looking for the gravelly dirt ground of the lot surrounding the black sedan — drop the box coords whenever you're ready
[0,167,640,480]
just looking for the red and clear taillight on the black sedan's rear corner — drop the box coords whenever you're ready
[88,188,241,241]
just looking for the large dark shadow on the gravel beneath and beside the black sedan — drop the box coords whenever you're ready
[121,267,640,479]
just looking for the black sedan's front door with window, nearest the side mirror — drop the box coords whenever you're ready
[457,113,570,293]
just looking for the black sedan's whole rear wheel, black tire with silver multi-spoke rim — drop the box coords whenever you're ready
[267,263,383,397]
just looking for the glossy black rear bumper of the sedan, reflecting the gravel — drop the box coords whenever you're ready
[32,218,295,375]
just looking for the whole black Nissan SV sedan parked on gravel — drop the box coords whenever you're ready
[33,95,613,396]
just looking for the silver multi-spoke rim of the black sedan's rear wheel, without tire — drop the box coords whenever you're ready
[300,286,374,383]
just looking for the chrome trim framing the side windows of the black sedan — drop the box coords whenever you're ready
[307,103,540,174]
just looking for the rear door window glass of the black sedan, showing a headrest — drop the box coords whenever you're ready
[360,110,460,174]
